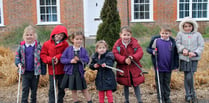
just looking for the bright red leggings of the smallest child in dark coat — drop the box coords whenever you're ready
[99,90,113,103]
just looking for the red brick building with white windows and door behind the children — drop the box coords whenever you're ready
[0,0,209,36]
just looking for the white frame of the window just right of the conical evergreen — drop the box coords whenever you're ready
[131,0,154,22]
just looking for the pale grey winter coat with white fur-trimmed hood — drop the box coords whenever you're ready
[176,17,204,62]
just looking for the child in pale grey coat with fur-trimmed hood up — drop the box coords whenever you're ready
[176,17,204,102]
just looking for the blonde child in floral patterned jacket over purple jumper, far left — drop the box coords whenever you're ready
[15,25,46,103]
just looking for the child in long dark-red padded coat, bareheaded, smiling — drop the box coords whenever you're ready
[112,26,144,103]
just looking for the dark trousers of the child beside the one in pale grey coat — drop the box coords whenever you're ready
[155,72,171,103]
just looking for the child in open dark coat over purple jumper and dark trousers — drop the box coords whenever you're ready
[147,27,179,103]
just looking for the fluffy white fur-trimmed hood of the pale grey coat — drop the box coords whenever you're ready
[179,17,198,32]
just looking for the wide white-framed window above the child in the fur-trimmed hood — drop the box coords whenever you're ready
[178,0,209,20]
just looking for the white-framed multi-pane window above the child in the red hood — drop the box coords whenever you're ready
[37,0,60,25]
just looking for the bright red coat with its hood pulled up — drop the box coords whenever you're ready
[40,25,70,75]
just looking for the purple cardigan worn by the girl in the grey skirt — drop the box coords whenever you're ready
[60,46,89,77]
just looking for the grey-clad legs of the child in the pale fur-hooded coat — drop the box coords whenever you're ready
[184,71,196,98]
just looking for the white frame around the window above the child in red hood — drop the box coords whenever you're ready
[36,0,61,25]
